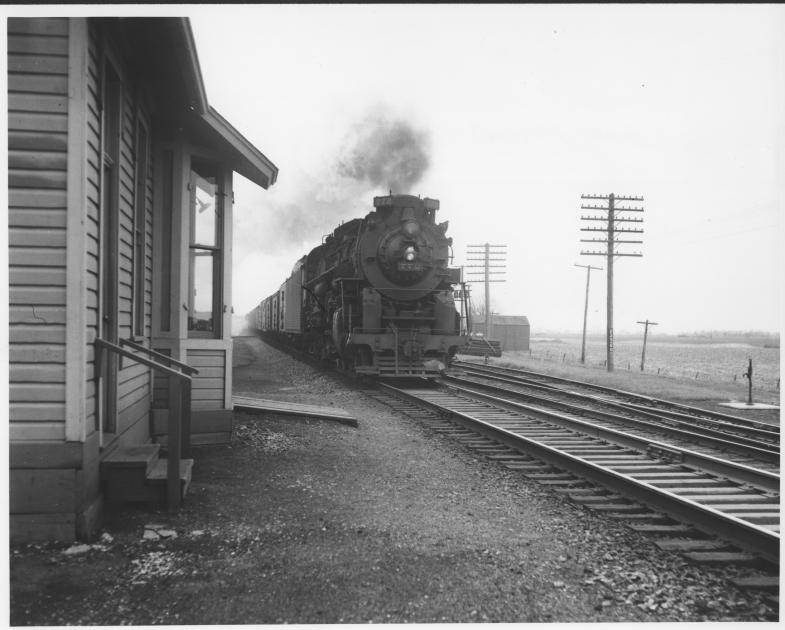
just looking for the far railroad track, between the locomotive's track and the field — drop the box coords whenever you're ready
[444,362,780,469]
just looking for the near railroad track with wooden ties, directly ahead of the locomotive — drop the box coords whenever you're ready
[377,384,780,576]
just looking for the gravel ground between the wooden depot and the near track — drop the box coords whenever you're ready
[10,338,777,625]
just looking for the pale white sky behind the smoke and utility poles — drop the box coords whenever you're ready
[189,5,785,332]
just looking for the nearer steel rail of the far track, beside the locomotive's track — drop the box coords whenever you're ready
[441,374,780,463]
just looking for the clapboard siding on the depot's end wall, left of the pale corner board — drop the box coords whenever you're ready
[7,18,68,440]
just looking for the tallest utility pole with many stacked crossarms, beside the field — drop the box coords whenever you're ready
[581,193,643,372]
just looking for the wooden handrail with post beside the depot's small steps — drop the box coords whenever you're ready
[94,337,194,512]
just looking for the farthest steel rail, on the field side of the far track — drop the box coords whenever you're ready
[452,361,779,434]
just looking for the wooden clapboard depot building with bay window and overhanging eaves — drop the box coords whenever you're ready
[7,18,278,541]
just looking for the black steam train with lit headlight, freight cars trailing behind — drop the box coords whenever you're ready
[246,194,468,378]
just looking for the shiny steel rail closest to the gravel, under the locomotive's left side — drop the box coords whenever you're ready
[380,384,779,564]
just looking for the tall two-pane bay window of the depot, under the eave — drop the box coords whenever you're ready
[188,164,223,337]
